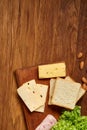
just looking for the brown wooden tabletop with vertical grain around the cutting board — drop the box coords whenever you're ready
[0,0,87,130]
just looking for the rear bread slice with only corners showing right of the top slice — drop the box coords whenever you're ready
[65,76,86,103]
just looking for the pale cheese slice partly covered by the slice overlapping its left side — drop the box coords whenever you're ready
[35,84,48,112]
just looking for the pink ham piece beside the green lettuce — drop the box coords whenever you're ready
[35,114,57,130]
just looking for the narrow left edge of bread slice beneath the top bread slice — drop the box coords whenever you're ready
[48,79,56,105]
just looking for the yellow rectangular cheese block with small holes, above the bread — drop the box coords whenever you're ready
[38,63,66,79]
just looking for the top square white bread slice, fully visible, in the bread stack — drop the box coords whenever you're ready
[52,78,81,109]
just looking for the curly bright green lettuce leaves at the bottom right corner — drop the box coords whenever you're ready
[51,106,87,130]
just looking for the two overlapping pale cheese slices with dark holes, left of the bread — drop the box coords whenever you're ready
[17,80,48,112]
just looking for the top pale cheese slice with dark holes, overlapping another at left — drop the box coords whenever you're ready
[17,81,44,112]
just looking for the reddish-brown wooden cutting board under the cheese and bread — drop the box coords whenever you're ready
[16,66,87,130]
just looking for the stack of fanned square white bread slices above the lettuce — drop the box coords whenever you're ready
[48,76,86,109]
